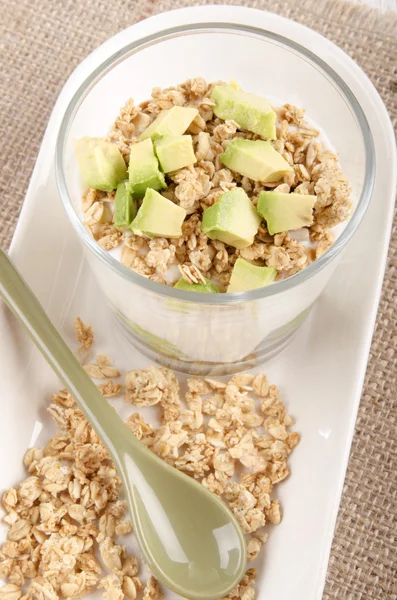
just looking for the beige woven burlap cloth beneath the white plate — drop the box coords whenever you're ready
[0,0,397,600]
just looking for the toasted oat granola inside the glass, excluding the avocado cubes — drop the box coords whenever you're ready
[82,77,352,292]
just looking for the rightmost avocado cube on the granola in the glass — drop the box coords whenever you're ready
[258,192,317,235]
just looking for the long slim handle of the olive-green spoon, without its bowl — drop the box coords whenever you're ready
[0,250,129,464]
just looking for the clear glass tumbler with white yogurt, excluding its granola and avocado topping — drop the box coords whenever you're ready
[56,23,375,375]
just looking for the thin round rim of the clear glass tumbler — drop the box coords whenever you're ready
[55,22,375,305]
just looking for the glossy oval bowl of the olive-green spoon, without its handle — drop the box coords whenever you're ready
[119,436,246,600]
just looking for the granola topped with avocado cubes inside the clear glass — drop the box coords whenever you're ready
[76,77,352,293]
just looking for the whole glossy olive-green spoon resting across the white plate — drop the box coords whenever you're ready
[0,251,247,600]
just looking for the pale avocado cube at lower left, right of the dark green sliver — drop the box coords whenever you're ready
[131,188,186,237]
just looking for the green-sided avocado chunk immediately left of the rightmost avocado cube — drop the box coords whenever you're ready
[201,187,261,249]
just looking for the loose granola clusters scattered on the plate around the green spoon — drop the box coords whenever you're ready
[0,319,299,600]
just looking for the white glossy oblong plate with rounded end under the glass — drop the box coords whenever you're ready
[0,6,396,600]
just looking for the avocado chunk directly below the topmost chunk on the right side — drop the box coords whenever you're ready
[220,140,293,183]
